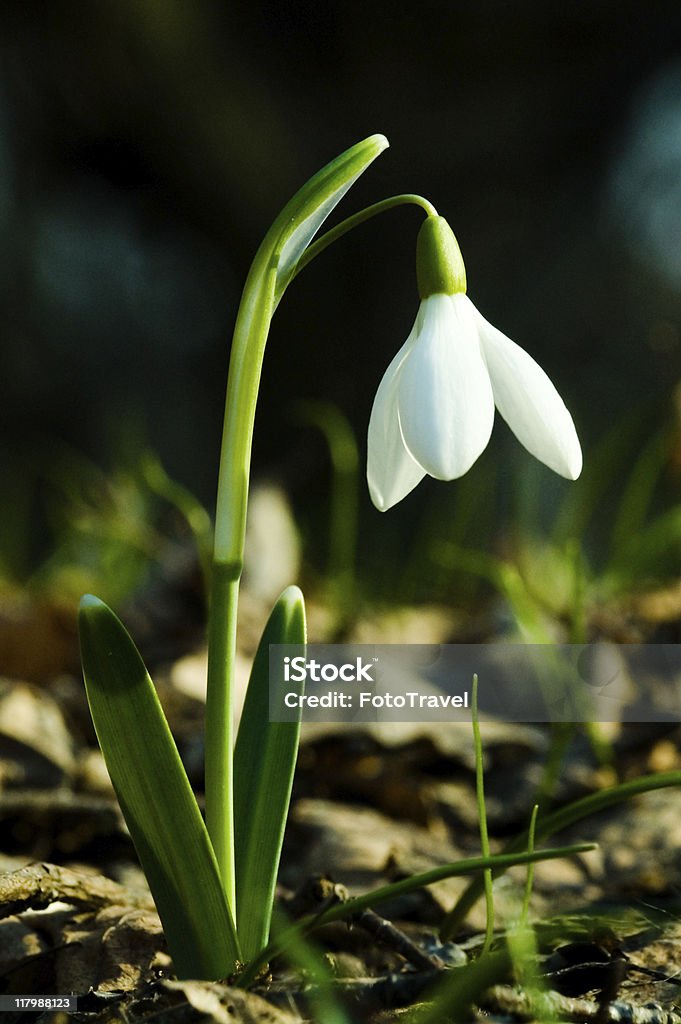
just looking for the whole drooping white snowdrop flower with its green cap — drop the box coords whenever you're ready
[367,216,582,512]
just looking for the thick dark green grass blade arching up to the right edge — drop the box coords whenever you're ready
[440,771,681,940]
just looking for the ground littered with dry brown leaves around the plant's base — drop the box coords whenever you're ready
[0,585,681,1024]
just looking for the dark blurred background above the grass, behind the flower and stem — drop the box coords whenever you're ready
[0,0,681,598]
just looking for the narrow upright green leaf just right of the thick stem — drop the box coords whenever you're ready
[235,587,305,961]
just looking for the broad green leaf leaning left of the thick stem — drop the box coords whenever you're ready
[79,594,241,980]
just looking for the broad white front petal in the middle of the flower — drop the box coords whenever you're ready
[398,295,495,480]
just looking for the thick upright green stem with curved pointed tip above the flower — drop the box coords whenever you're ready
[206,135,388,920]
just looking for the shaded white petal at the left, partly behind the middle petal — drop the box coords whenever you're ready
[367,321,426,512]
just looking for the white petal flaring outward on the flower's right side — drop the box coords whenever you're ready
[471,303,582,480]
